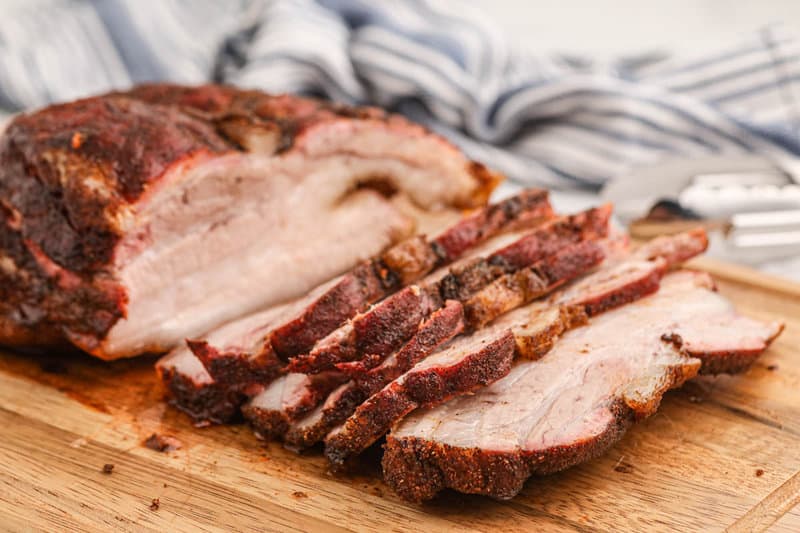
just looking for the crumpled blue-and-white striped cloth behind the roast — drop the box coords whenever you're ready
[0,0,800,188]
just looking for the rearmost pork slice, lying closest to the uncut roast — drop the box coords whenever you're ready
[190,189,551,388]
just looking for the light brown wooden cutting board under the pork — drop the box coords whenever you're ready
[0,260,800,532]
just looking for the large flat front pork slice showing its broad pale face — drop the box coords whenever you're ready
[383,272,782,501]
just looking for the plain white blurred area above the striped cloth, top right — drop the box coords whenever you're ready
[484,0,800,60]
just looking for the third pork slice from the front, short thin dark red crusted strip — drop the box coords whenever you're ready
[283,300,464,449]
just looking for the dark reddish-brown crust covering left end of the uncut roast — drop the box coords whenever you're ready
[0,95,232,352]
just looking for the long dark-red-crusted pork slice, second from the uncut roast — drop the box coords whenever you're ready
[289,206,611,372]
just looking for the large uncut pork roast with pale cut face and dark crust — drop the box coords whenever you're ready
[0,85,505,359]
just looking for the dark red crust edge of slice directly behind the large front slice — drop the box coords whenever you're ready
[325,331,515,466]
